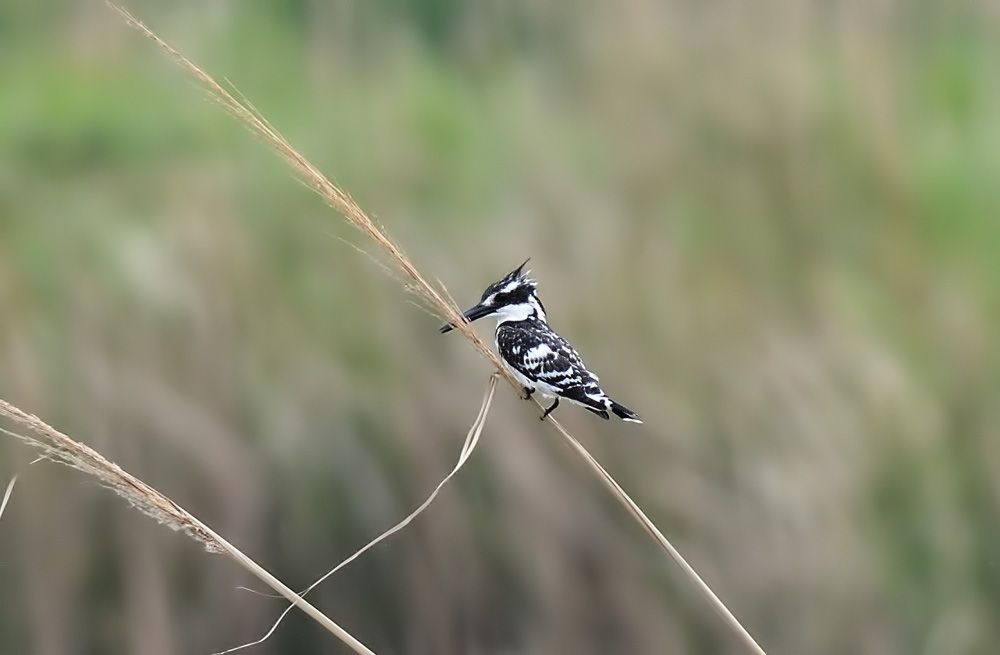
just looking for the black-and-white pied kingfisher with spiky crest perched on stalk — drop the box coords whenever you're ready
[441,260,642,423]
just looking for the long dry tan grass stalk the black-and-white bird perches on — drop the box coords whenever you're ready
[108,6,764,653]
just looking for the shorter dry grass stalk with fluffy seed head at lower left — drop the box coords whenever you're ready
[0,400,374,655]
